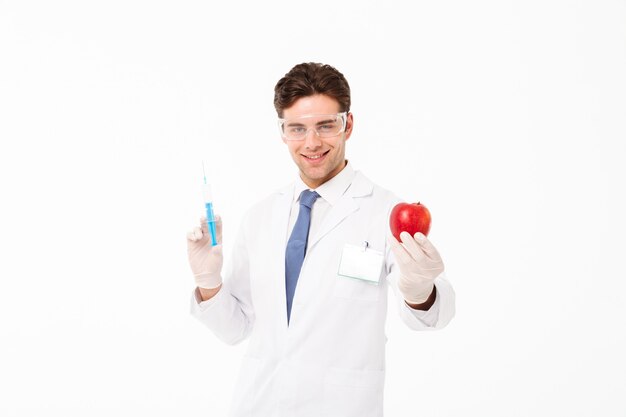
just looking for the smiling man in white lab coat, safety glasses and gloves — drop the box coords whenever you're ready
[187,63,454,417]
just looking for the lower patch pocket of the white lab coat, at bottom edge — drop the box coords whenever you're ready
[324,368,385,417]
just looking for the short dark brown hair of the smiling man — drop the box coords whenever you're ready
[274,62,350,117]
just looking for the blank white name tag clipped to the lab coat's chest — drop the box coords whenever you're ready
[339,244,384,284]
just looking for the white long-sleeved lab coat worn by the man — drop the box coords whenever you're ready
[191,171,454,417]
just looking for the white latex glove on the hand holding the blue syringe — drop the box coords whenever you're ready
[187,216,224,289]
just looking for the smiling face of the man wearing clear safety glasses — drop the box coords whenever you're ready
[283,94,353,188]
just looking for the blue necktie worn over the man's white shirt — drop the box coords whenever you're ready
[285,190,319,324]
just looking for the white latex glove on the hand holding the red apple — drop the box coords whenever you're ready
[387,232,443,304]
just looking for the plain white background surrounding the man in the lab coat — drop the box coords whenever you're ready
[0,0,626,417]
